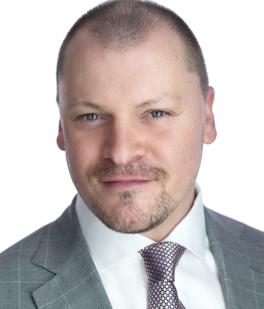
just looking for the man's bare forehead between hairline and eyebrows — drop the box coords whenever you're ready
[59,25,198,106]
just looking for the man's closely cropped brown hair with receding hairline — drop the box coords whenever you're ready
[56,0,209,100]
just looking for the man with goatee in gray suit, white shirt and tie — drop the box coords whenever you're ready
[0,0,264,309]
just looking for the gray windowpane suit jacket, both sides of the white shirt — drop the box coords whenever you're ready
[0,196,264,309]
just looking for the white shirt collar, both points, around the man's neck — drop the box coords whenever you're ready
[76,185,206,269]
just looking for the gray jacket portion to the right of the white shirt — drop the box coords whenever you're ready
[205,209,264,309]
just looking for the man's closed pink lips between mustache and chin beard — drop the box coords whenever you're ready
[100,177,153,189]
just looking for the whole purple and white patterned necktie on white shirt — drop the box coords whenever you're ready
[139,242,185,309]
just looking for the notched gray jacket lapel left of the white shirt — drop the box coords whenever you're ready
[32,201,111,309]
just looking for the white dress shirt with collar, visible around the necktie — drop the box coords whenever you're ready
[76,187,226,309]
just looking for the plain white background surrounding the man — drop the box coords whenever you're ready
[0,0,264,251]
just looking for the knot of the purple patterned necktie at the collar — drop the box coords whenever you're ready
[139,242,185,282]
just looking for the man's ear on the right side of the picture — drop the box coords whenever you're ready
[204,87,217,144]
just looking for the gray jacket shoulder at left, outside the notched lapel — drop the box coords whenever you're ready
[0,221,54,309]
